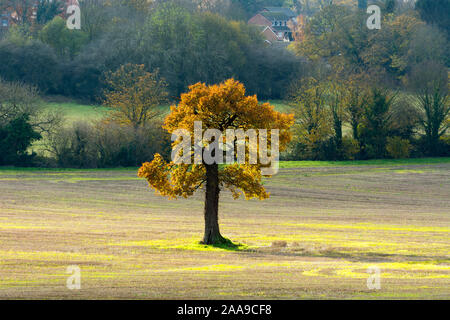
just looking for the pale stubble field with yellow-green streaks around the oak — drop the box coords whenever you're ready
[0,158,450,299]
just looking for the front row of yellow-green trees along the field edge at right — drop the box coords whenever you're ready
[287,69,450,160]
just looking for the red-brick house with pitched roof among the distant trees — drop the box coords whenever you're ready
[248,7,297,43]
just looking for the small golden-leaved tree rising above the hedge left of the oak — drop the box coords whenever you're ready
[103,64,167,128]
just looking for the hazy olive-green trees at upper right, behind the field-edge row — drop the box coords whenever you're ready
[292,1,450,88]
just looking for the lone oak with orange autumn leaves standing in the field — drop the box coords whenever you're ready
[138,79,294,244]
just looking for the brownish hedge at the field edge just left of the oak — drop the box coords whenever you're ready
[47,122,170,168]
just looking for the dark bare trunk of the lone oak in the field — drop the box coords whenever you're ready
[203,163,226,244]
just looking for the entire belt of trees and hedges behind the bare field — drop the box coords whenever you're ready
[0,0,449,167]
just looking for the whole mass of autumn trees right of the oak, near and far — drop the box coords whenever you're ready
[288,0,450,160]
